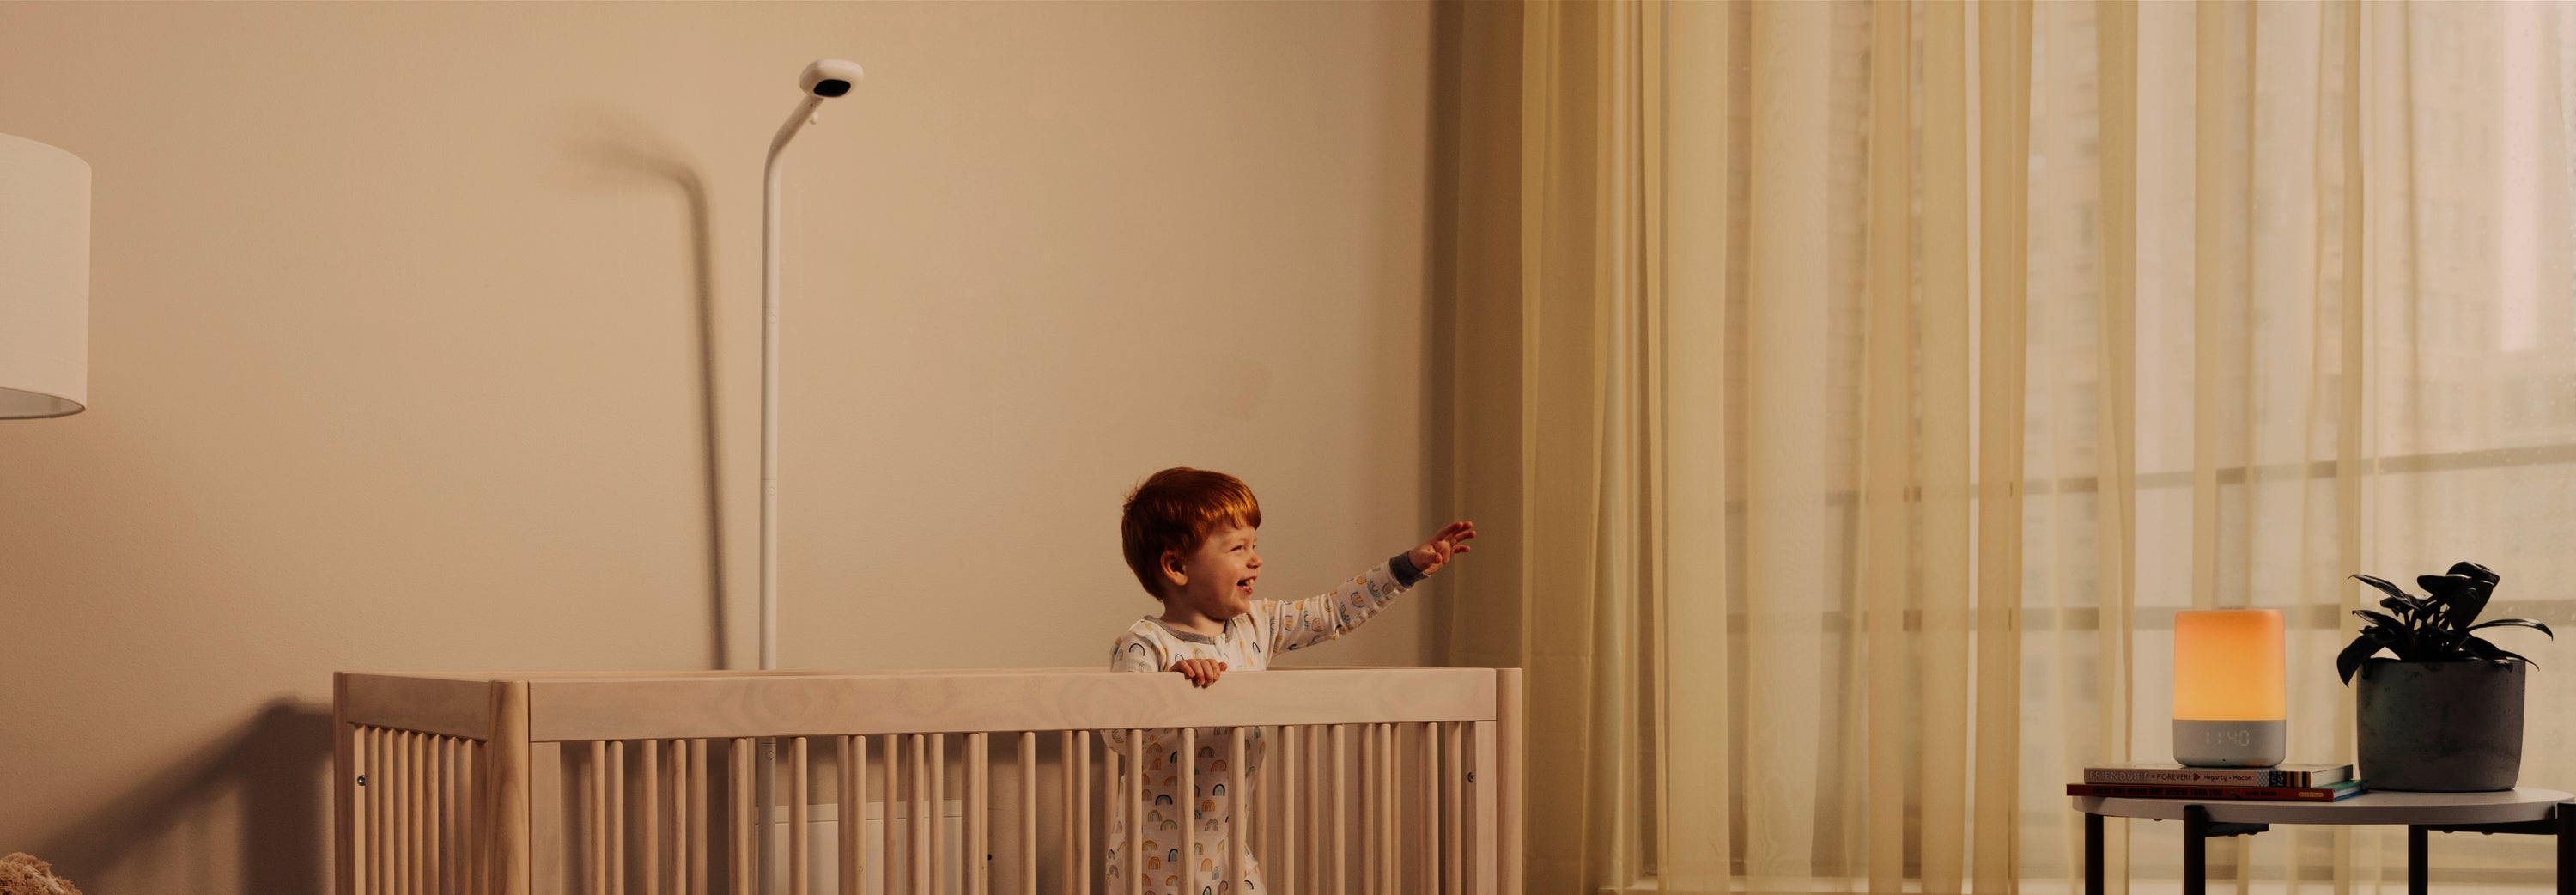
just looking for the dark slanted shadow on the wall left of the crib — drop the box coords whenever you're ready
[36,699,332,895]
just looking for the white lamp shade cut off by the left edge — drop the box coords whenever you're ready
[0,134,90,417]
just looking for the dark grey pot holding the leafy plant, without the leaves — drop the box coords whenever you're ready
[2352,658,2527,792]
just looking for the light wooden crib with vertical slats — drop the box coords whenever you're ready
[332,668,1522,895]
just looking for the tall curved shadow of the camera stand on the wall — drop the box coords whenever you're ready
[567,111,732,671]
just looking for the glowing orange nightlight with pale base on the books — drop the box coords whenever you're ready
[2174,609,2290,769]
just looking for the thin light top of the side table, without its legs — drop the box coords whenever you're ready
[2074,787,2576,825]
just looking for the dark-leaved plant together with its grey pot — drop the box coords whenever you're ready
[2334,563,2558,792]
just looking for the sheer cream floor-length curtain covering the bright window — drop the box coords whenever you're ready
[1432,0,2576,892]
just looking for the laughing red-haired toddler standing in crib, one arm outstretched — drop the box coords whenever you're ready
[1108,467,1476,895]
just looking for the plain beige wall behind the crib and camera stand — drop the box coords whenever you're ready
[0,3,1443,895]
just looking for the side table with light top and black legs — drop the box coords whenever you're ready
[2074,789,2576,895]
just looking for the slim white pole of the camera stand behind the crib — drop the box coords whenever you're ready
[752,95,824,892]
